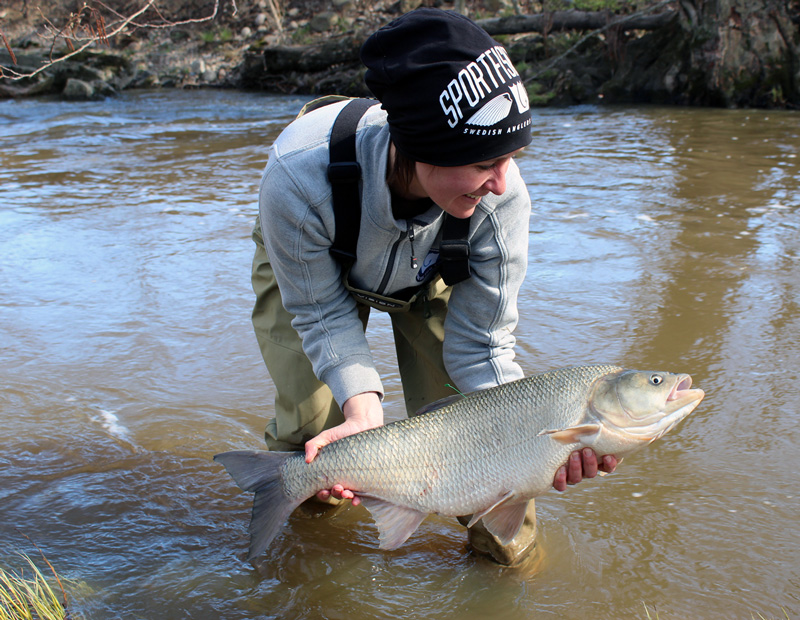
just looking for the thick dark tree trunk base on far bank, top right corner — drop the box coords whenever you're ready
[603,0,800,108]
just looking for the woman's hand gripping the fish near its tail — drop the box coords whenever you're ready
[306,392,383,506]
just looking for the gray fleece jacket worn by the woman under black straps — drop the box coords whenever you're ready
[259,103,530,405]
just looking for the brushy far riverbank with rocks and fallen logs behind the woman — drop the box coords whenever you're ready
[0,0,800,108]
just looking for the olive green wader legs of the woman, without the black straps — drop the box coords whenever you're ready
[252,219,536,565]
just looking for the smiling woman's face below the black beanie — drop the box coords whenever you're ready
[408,149,522,218]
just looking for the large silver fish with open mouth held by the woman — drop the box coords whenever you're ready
[214,365,704,558]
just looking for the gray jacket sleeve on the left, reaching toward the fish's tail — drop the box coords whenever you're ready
[259,148,383,406]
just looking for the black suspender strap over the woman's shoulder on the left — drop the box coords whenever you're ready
[328,99,377,267]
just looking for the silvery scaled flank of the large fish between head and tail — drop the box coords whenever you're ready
[283,366,622,516]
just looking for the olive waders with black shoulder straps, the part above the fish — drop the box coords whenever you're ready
[252,95,470,450]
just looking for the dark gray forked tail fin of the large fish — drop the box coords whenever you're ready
[214,450,307,560]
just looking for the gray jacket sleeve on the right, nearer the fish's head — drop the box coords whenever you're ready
[444,163,531,392]
